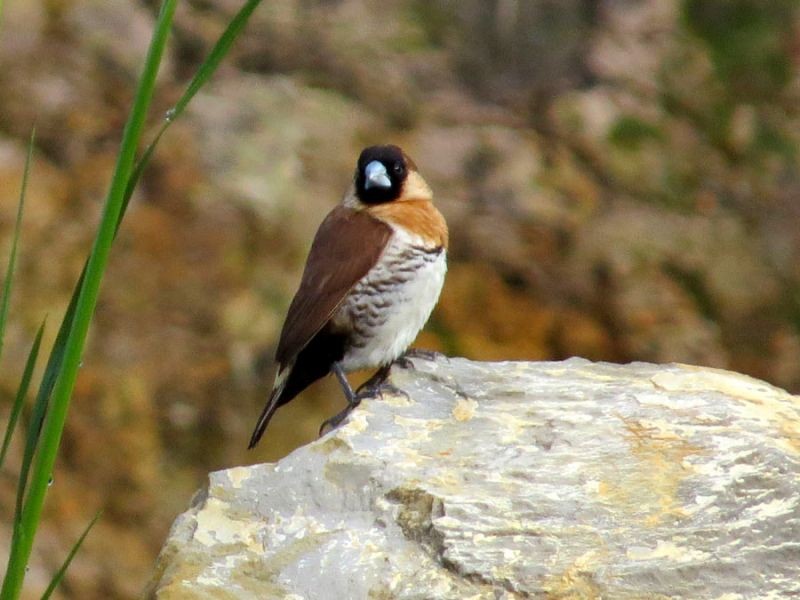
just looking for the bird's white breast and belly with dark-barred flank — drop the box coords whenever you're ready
[333,227,447,371]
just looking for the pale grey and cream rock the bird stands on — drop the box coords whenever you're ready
[148,357,800,600]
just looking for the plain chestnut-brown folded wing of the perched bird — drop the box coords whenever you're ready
[275,206,392,365]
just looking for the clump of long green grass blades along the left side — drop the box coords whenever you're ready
[0,0,260,600]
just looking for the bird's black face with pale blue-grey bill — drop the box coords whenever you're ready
[355,146,408,204]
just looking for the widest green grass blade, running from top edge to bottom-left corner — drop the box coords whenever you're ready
[0,0,177,599]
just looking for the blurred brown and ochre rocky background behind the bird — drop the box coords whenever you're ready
[0,0,800,598]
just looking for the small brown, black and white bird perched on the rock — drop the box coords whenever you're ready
[248,145,449,449]
